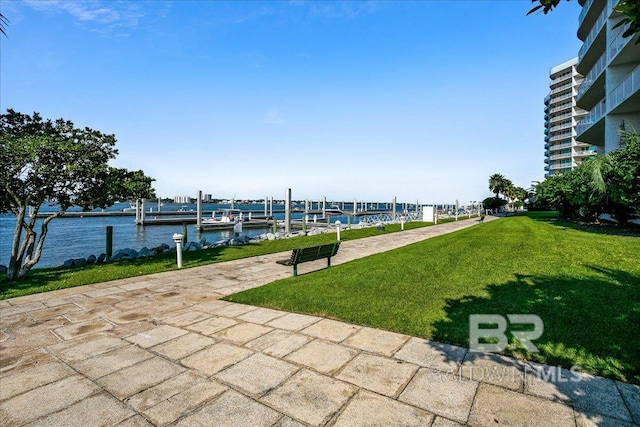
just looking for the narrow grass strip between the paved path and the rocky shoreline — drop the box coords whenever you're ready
[0,222,440,299]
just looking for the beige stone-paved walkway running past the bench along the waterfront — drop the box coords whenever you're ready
[0,217,640,427]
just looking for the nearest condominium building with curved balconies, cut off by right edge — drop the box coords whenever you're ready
[576,0,640,153]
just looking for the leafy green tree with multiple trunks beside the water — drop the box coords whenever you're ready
[0,109,154,280]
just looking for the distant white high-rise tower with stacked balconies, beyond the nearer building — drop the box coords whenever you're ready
[544,58,596,177]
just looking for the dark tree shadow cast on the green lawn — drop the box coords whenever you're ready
[432,267,640,384]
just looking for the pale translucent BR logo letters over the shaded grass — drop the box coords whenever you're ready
[469,314,544,353]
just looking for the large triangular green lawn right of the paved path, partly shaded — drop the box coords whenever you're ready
[226,214,640,383]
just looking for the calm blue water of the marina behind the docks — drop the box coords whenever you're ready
[0,203,362,268]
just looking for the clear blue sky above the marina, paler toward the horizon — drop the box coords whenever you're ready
[0,0,580,203]
